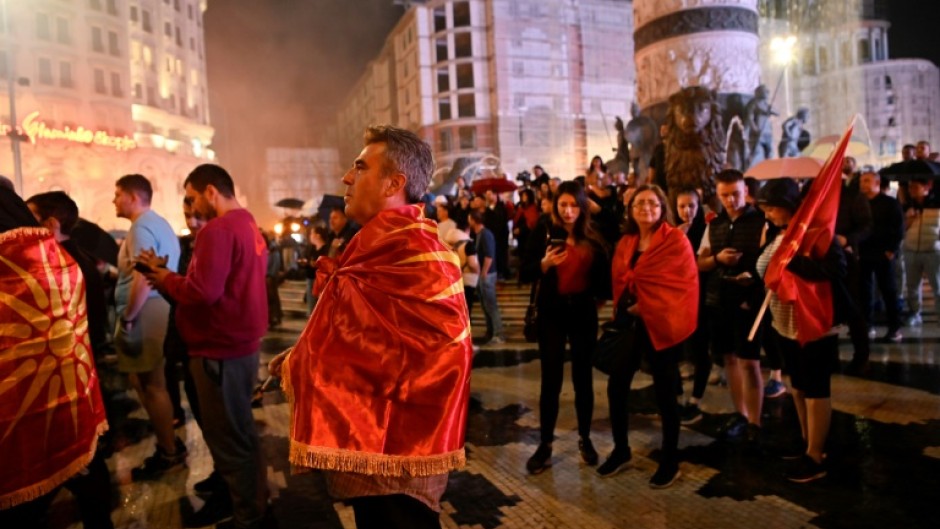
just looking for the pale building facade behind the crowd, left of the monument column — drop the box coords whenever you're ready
[337,0,635,178]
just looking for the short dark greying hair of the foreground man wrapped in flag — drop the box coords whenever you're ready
[363,125,434,204]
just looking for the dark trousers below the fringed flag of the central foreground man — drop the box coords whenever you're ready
[350,494,441,529]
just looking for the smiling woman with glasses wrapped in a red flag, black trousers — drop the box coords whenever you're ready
[597,185,699,488]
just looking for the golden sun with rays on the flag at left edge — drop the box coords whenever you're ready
[0,233,95,445]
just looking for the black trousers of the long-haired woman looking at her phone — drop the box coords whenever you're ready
[537,294,597,443]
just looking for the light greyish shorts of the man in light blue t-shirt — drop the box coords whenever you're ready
[114,297,170,373]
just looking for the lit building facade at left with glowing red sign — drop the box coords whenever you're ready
[0,0,214,229]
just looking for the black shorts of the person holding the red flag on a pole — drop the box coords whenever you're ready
[778,335,839,399]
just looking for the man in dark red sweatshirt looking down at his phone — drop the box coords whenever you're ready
[138,164,268,528]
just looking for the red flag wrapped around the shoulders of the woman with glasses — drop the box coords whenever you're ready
[613,223,699,351]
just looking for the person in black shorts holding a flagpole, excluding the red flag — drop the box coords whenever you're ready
[757,178,848,483]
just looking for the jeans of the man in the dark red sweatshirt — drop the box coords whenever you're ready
[190,353,268,528]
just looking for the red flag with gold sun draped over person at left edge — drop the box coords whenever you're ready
[0,228,107,509]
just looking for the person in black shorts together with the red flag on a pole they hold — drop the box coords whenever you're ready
[757,122,852,483]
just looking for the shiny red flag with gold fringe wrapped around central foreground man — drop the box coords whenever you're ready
[283,206,473,476]
